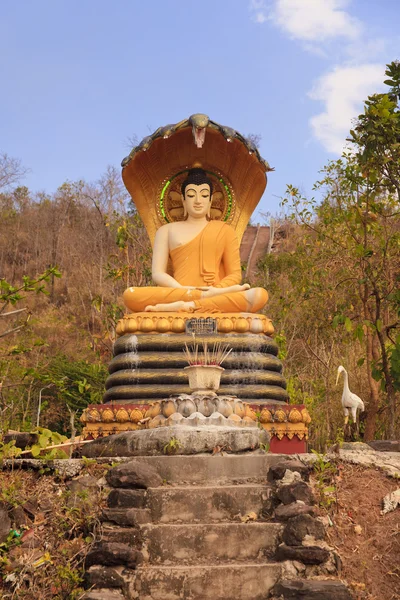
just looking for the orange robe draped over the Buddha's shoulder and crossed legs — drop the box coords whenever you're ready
[123,221,268,312]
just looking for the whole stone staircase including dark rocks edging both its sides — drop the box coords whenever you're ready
[85,451,351,600]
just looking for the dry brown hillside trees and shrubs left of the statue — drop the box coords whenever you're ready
[0,159,151,433]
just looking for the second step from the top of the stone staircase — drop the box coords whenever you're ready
[108,484,271,523]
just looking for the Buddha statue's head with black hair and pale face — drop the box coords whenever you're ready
[181,167,213,220]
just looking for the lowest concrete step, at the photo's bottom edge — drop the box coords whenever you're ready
[130,563,281,600]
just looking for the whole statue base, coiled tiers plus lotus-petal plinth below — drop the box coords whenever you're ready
[91,312,310,454]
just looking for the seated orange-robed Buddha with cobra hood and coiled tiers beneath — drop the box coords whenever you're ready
[99,115,287,404]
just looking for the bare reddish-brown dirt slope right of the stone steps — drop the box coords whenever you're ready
[320,464,400,600]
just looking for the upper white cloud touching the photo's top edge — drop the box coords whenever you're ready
[250,0,362,43]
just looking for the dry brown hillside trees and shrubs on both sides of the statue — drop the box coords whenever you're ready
[0,63,400,449]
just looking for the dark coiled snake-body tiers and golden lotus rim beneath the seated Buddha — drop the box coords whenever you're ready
[104,313,288,403]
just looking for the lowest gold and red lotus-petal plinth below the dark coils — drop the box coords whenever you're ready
[81,394,311,454]
